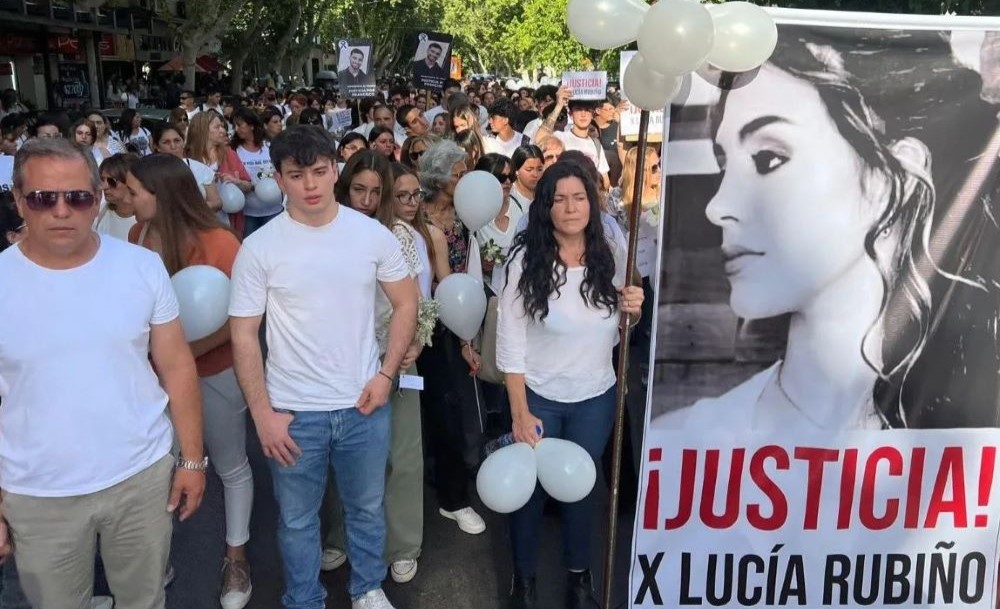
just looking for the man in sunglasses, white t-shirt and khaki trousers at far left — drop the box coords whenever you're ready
[0,138,207,609]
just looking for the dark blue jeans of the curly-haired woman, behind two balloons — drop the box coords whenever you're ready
[510,386,615,577]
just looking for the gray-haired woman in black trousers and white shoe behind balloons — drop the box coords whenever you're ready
[417,140,486,535]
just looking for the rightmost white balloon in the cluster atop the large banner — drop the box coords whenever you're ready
[708,2,778,72]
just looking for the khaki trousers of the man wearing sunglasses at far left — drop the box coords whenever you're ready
[3,455,174,609]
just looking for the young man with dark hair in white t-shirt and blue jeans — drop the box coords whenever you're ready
[229,126,419,609]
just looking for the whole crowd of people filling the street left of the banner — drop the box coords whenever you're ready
[0,76,660,609]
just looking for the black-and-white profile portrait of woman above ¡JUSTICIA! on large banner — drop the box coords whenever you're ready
[652,26,1000,432]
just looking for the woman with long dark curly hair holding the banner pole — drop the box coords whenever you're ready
[497,161,643,609]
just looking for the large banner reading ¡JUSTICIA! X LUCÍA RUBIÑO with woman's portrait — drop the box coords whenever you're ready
[626,10,1000,609]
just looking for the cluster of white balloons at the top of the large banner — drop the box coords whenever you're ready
[566,0,778,110]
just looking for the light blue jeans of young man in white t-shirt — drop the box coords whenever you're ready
[269,404,390,609]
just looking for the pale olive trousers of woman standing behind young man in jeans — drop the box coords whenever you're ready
[323,366,424,563]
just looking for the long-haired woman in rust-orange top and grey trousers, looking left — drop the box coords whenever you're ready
[126,153,253,609]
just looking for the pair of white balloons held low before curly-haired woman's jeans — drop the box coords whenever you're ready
[476,438,597,514]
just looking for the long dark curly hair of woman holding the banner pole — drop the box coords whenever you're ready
[507,162,618,322]
